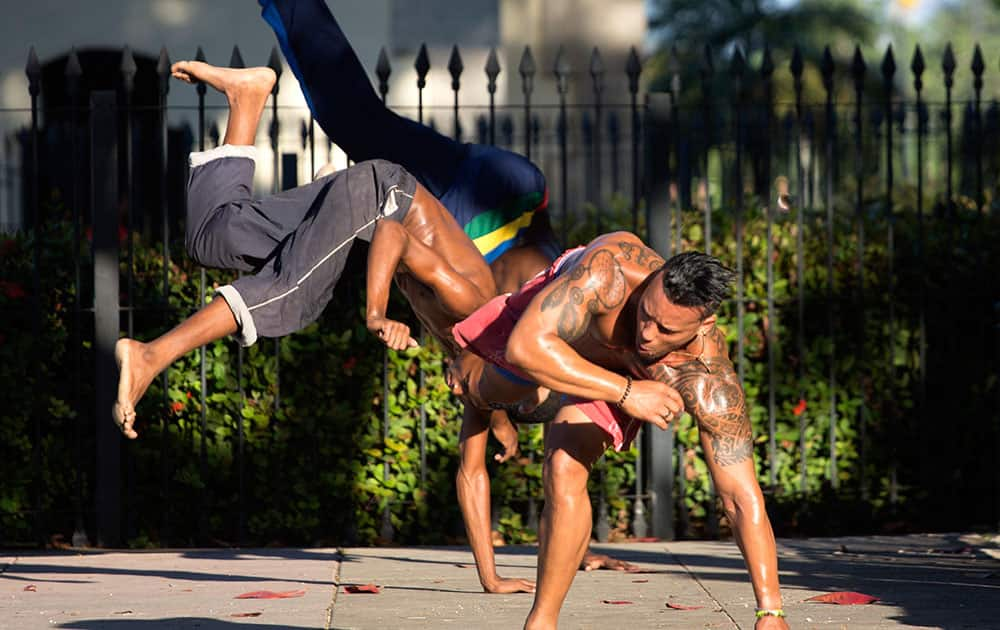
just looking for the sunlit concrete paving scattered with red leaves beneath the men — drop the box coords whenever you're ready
[0,534,1000,630]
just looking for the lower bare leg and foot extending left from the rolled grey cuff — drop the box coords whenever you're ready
[112,298,237,440]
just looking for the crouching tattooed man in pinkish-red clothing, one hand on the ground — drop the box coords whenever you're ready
[453,232,788,630]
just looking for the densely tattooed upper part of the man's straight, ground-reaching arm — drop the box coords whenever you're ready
[655,361,753,466]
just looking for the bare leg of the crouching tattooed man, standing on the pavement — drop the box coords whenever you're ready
[524,407,609,630]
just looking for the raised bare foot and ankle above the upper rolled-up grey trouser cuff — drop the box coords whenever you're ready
[170,61,276,146]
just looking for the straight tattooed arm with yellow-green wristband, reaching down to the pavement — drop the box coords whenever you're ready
[655,361,788,629]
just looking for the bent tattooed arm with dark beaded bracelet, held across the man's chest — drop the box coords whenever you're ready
[507,234,682,428]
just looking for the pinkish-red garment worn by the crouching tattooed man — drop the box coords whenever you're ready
[452,247,641,451]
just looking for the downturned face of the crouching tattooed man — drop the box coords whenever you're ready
[635,275,715,363]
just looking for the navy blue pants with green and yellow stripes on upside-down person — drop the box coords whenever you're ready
[259,0,561,262]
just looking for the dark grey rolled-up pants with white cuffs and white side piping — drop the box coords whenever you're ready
[185,145,417,346]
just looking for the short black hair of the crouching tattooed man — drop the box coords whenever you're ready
[663,252,736,318]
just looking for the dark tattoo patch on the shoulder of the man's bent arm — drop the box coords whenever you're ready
[541,249,628,341]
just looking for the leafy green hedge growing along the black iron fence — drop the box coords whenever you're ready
[0,191,1000,546]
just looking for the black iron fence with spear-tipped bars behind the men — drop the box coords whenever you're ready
[0,39,1000,545]
